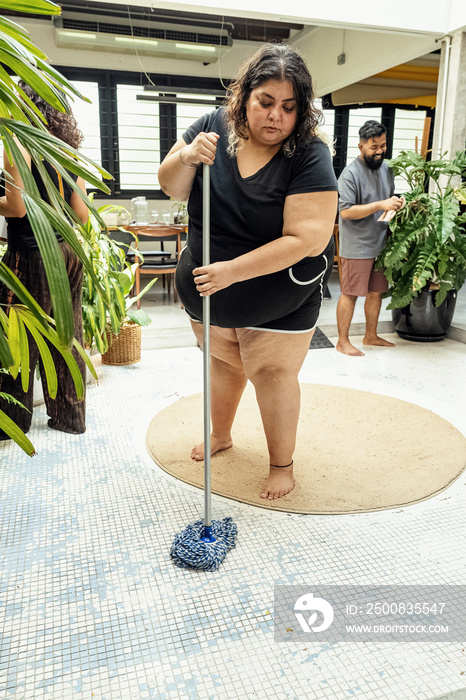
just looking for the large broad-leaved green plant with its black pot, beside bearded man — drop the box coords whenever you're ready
[376,151,466,342]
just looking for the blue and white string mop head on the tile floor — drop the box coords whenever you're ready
[170,518,238,571]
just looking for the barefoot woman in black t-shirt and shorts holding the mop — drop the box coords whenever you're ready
[159,44,338,500]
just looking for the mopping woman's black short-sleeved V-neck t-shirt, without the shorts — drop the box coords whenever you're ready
[183,108,337,263]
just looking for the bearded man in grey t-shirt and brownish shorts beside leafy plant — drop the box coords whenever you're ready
[337,120,404,356]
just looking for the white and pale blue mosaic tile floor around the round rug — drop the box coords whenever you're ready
[0,339,466,700]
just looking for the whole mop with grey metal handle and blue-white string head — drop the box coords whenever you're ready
[170,164,238,571]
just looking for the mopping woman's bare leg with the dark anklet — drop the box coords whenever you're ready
[238,329,313,500]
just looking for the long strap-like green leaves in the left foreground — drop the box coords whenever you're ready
[0,0,111,455]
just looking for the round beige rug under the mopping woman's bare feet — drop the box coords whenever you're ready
[147,384,466,514]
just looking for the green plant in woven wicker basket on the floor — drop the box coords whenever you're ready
[82,205,156,364]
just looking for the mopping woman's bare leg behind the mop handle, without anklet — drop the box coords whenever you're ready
[191,323,247,461]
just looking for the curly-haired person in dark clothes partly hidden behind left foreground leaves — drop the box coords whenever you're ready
[0,81,88,440]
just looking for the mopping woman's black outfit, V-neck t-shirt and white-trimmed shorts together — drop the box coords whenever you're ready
[176,109,337,333]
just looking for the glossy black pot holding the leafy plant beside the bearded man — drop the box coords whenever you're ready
[392,289,457,343]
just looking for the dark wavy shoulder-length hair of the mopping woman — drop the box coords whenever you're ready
[225,44,323,155]
